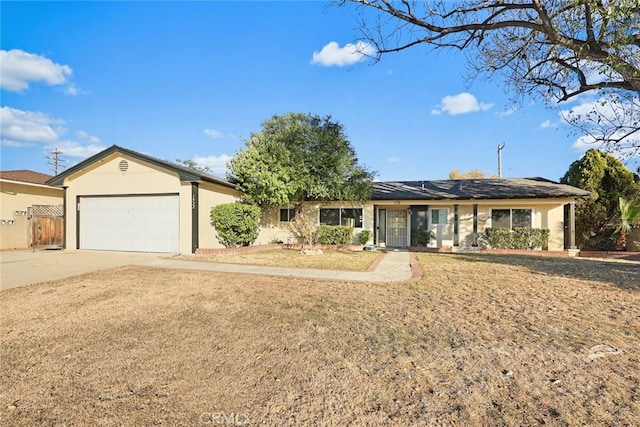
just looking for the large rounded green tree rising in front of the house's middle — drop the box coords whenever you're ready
[228,113,374,212]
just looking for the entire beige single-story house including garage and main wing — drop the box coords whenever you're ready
[47,145,589,253]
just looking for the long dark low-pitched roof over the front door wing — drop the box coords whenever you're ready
[372,178,589,200]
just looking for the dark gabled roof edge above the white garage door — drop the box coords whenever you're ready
[47,145,236,189]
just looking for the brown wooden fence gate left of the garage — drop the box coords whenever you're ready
[29,205,64,250]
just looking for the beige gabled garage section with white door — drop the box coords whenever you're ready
[48,145,240,253]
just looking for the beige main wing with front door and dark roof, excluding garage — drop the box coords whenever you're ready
[255,178,589,250]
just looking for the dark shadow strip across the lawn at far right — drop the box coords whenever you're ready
[454,254,640,291]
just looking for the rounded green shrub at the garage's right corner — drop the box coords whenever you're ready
[211,203,261,248]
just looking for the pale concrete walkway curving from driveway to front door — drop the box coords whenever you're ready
[137,251,413,282]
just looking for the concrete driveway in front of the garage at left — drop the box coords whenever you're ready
[0,250,167,291]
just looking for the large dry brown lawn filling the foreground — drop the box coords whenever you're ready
[0,254,640,426]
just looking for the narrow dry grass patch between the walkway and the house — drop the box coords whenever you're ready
[173,249,382,271]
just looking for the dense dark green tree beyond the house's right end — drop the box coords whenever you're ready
[561,150,640,249]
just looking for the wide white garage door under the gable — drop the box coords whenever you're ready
[79,195,180,253]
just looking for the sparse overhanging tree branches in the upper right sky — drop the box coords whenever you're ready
[338,0,640,156]
